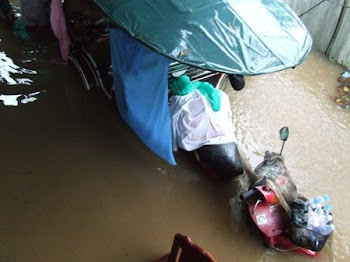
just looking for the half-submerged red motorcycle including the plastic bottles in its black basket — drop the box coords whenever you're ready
[240,127,334,256]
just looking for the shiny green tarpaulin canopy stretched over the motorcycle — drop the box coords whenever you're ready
[94,0,312,75]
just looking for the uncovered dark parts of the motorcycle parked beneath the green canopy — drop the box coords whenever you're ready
[68,14,245,181]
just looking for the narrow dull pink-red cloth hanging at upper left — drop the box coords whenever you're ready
[50,0,69,62]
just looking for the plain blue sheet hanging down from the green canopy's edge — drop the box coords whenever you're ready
[110,29,176,165]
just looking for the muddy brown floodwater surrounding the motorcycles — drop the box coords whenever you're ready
[0,9,350,262]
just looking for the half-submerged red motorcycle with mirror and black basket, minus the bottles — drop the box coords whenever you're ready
[240,127,333,257]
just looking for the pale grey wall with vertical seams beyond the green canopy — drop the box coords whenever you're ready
[283,0,350,68]
